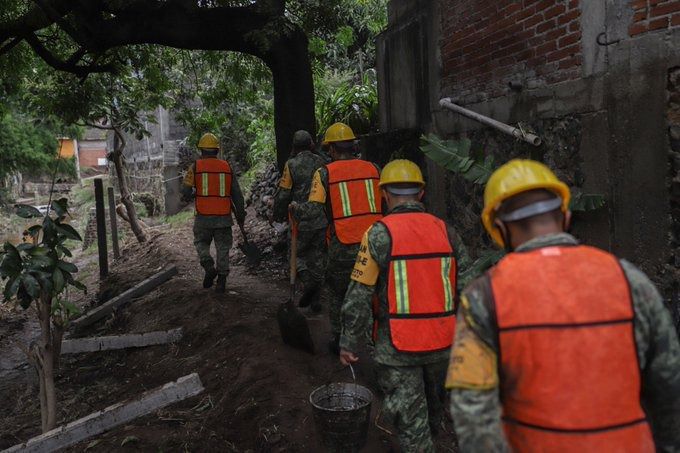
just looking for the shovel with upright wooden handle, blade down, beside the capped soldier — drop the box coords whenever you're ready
[276,209,314,354]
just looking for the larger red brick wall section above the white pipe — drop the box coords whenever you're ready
[441,0,584,102]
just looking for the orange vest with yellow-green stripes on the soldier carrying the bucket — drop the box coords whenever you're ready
[380,212,457,353]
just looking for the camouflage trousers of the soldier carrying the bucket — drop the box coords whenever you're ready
[376,360,447,453]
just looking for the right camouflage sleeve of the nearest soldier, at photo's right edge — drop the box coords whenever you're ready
[621,260,680,452]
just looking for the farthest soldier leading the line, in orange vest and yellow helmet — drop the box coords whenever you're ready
[182,133,246,293]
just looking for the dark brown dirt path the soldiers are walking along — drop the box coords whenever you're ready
[0,213,460,452]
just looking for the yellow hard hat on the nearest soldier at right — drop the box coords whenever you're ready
[482,159,571,247]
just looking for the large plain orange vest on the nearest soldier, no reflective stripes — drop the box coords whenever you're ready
[489,246,654,453]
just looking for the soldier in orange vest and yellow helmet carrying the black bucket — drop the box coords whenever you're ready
[340,160,469,452]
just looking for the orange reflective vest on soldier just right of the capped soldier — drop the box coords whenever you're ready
[326,159,382,245]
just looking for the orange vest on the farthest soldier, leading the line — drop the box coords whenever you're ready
[194,159,233,216]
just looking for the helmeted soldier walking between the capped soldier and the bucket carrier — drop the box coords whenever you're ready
[294,123,381,354]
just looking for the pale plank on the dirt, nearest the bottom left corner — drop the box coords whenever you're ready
[2,373,204,453]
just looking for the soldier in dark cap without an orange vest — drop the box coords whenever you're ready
[274,130,326,312]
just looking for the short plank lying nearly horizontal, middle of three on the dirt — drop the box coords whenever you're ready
[61,327,183,354]
